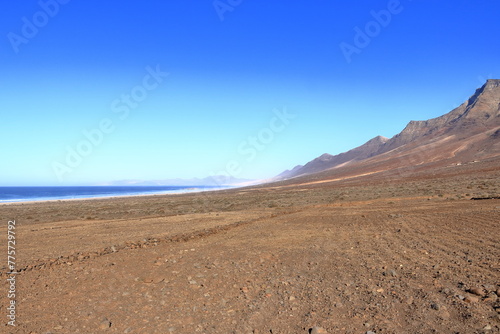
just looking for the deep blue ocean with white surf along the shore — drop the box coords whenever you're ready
[0,186,221,203]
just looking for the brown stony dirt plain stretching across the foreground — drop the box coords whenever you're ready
[0,162,500,334]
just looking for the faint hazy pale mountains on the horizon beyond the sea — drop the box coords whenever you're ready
[104,175,256,187]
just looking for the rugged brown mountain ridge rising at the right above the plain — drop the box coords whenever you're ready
[272,79,500,181]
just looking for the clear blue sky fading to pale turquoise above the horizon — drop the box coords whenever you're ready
[0,0,500,186]
